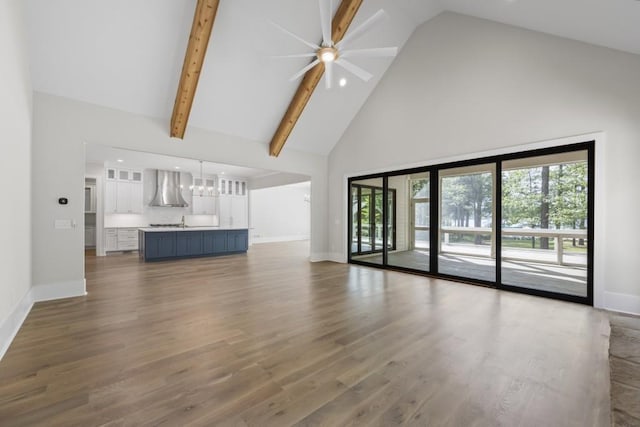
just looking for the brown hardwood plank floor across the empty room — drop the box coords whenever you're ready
[0,242,610,427]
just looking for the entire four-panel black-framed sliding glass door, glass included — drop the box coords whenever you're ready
[349,141,595,304]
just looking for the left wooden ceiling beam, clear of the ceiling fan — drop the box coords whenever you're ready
[171,0,220,139]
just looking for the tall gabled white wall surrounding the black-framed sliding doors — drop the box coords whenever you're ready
[329,13,640,313]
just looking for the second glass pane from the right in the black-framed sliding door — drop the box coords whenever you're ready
[438,164,496,282]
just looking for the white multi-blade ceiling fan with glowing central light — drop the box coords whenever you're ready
[272,0,398,89]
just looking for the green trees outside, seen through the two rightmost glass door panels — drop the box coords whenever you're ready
[441,162,587,252]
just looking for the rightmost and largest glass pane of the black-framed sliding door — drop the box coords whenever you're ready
[502,150,589,297]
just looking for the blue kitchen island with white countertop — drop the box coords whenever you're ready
[138,227,249,261]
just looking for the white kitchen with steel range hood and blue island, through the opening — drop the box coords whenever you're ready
[84,146,268,261]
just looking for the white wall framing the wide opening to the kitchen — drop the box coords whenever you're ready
[33,92,327,300]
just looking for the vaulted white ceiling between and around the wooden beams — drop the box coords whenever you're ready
[26,0,640,155]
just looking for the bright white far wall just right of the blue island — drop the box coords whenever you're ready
[249,182,311,243]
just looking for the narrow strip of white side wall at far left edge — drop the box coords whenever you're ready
[0,0,32,358]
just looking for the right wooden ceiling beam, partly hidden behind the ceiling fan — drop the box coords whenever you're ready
[269,0,363,157]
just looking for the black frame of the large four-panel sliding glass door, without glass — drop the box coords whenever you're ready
[347,140,595,306]
